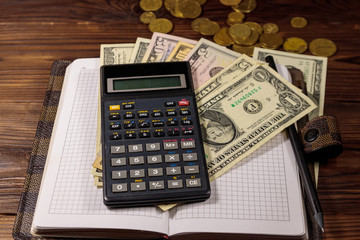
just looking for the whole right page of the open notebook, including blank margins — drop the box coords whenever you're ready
[170,132,306,236]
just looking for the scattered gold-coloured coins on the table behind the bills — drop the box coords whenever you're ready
[140,0,337,57]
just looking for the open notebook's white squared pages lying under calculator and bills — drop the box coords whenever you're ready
[32,59,307,239]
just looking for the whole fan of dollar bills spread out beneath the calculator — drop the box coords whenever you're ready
[91,33,327,187]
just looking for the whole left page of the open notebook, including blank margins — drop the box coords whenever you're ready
[32,59,168,233]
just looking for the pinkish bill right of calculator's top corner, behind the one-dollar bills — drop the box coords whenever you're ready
[184,38,241,89]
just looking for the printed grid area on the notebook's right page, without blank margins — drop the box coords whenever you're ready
[174,134,290,221]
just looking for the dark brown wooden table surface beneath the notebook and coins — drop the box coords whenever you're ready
[0,0,360,239]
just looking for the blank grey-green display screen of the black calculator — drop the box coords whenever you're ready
[113,76,181,91]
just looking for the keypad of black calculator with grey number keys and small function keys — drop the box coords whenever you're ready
[105,98,207,205]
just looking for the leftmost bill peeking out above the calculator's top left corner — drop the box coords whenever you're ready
[100,43,135,66]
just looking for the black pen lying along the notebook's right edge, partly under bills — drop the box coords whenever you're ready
[265,56,324,232]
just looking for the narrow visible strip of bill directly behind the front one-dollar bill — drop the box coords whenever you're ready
[195,54,257,101]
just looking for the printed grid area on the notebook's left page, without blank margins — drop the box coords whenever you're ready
[49,68,161,218]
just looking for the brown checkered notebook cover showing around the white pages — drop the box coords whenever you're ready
[13,60,322,240]
